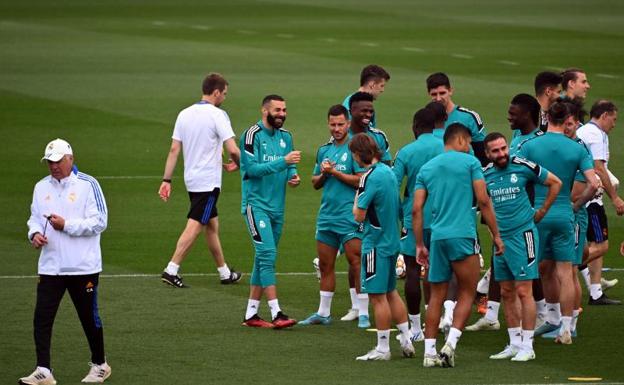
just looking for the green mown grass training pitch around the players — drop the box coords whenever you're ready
[0,0,624,384]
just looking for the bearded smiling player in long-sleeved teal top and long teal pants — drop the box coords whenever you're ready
[240,95,301,329]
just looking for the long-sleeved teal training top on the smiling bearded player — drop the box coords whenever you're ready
[240,121,297,214]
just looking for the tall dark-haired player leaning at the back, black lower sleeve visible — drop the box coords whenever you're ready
[427,72,488,166]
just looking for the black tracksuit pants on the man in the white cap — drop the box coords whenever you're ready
[33,274,105,368]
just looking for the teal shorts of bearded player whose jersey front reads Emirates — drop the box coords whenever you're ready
[493,225,539,281]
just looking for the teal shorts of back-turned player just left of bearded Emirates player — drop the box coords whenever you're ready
[429,238,481,283]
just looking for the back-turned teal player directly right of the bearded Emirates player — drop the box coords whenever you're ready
[519,102,598,344]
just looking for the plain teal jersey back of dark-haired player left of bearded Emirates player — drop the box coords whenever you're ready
[415,151,483,242]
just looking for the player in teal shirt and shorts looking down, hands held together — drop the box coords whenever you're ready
[299,104,366,325]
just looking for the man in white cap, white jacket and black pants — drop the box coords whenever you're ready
[19,139,111,385]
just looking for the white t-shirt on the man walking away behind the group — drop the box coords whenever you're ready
[172,101,235,192]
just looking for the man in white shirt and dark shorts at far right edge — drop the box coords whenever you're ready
[577,99,624,305]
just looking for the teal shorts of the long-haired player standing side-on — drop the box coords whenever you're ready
[360,249,397,294]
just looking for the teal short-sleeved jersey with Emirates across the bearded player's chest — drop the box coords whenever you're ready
[483,156,548,235]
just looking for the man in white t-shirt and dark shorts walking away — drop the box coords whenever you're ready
[158,73,242,288]
